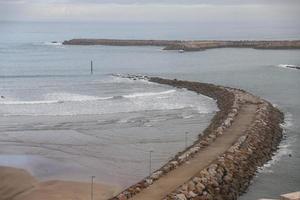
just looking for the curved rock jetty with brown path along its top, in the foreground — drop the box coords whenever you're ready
[112,77,283,200]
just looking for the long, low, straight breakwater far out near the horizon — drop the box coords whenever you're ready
[63,39,300,51]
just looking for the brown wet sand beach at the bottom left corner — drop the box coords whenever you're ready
[0,167,119,200]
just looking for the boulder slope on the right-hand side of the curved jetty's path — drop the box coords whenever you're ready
[165,99,282,200]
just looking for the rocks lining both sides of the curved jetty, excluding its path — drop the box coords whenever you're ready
[111,76,283,200]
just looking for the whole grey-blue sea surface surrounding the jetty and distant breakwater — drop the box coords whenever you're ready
[0,22,300,200]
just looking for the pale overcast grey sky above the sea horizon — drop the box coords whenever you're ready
[0,0,300,23]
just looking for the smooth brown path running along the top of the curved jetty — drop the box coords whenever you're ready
[130,95,258,200]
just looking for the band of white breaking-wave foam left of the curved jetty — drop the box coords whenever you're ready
[0,86,217,115]
